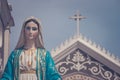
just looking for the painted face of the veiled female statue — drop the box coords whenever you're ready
[25,21,38,40]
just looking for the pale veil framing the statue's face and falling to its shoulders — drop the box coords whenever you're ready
[15,17,44,49]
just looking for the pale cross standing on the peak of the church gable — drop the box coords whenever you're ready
[70,11,86,35]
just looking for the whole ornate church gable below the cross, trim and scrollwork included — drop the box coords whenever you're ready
[51,35,120,80]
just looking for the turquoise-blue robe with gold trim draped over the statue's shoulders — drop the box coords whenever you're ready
[0,48,62,80]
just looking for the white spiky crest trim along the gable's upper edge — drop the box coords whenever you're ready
[51,34,120,67]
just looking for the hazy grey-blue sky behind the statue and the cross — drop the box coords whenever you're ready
[8,0,120,57]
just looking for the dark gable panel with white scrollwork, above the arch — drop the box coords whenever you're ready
[56,49,120,80]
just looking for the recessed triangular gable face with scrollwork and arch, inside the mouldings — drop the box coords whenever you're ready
[56,48,120,80]
